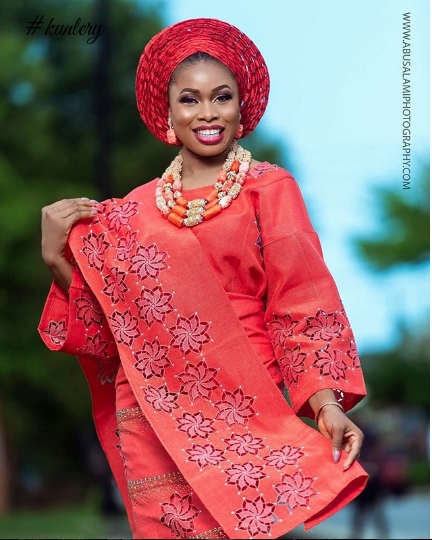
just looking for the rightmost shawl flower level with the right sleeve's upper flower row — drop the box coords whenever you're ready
[169,313,210,355]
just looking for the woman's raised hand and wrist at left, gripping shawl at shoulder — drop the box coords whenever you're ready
[41,198,98,291]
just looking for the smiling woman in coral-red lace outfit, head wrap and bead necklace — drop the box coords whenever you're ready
[39,19,367,538]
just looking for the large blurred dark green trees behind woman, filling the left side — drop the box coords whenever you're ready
[0,0,286,503]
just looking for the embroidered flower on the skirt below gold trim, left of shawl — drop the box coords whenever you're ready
[160,493,201,538]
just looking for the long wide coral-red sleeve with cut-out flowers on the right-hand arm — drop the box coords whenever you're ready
[258,173,366,418]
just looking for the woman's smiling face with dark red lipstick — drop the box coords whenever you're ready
[169,61,240,157]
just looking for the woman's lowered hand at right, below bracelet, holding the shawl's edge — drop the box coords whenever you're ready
[317,405,364,471]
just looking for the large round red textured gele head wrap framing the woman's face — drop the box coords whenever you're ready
[135,19,270,144]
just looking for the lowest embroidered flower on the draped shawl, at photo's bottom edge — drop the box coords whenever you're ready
[235,495,278,538]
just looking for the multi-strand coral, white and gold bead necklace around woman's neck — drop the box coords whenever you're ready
[155,141,252,227]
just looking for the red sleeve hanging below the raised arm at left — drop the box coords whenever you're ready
[38,266,117,359]
